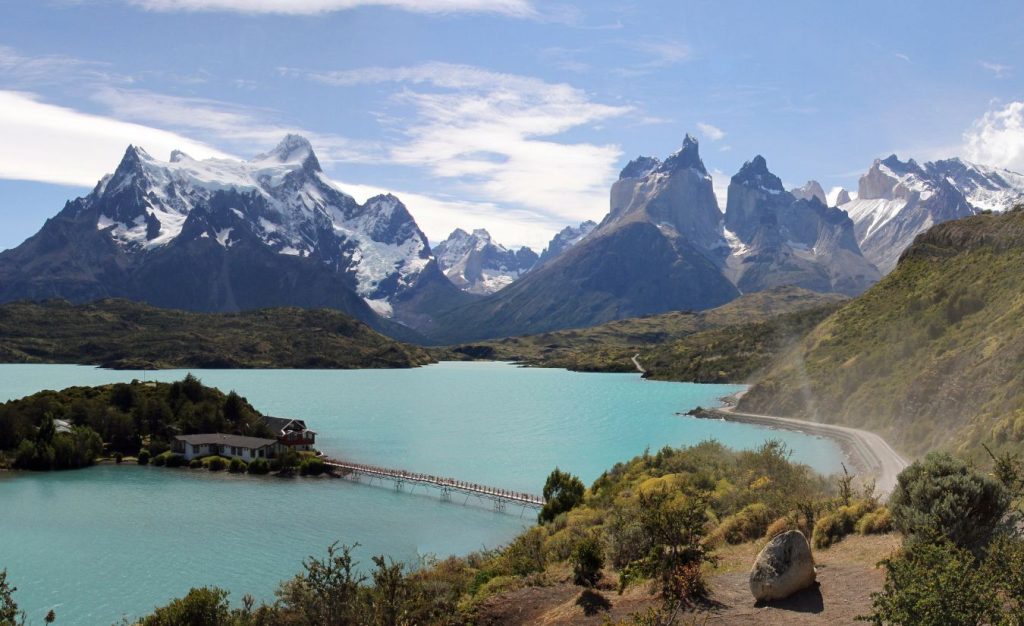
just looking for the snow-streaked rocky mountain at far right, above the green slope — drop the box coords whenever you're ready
[840,155,1024,273]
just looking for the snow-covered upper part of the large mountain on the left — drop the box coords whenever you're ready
[71,134,444,311]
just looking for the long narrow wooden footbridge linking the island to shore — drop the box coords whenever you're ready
[324,458,545,511]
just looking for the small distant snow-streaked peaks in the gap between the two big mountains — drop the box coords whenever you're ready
[434,228,539,294]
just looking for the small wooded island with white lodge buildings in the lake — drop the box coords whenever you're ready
[0,374,324,474]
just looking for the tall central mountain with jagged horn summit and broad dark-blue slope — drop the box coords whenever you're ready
[419,136,738,343]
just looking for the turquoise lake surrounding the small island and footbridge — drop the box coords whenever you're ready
[0,363,842,625]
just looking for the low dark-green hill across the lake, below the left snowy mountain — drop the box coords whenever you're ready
[0,300,433,369]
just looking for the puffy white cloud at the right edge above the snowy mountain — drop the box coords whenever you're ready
[964,100,1024,171]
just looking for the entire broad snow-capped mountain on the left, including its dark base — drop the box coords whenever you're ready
[0,135,459,323]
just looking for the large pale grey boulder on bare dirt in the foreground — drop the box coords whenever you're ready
[751,531,815,602]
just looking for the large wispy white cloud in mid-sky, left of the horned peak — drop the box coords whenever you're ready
[282,62,632,223]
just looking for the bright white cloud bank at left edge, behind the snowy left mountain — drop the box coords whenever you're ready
[0,90,224,186]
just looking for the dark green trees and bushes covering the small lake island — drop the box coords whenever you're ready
[0,375,269,469]
